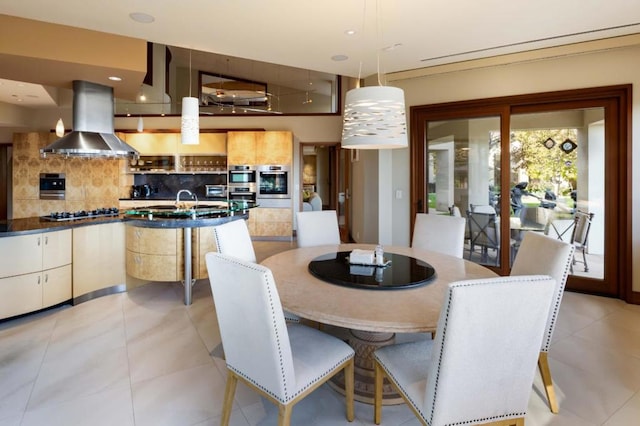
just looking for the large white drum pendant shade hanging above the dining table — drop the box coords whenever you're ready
[342,86,408,149]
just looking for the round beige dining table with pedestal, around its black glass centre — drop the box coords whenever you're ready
[261,244,496,404]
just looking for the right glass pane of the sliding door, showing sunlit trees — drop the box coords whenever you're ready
[509,108,606,279]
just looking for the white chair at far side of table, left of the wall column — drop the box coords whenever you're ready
[296,210,340,247]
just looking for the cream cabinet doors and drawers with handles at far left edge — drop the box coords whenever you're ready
[0,229,71,318]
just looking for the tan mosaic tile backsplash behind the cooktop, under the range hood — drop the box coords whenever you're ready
[13,132,122,219]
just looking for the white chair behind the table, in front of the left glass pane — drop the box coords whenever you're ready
[411,213,467,259]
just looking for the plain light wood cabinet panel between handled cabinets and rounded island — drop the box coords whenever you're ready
[73,222,126,299]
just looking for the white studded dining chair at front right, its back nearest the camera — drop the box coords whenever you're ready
[374,275,555,426]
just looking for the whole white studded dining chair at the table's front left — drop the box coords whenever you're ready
[205,253,354,426]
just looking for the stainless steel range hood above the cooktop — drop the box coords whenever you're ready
[40,80,139,158]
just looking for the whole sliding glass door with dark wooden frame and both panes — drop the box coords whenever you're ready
[410,86,633,299]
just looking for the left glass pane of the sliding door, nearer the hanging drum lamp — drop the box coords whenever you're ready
[422,117,508,267]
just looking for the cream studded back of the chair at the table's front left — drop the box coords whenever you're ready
[206,253,295,402]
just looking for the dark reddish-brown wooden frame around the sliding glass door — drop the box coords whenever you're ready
[410,84,640,304]
